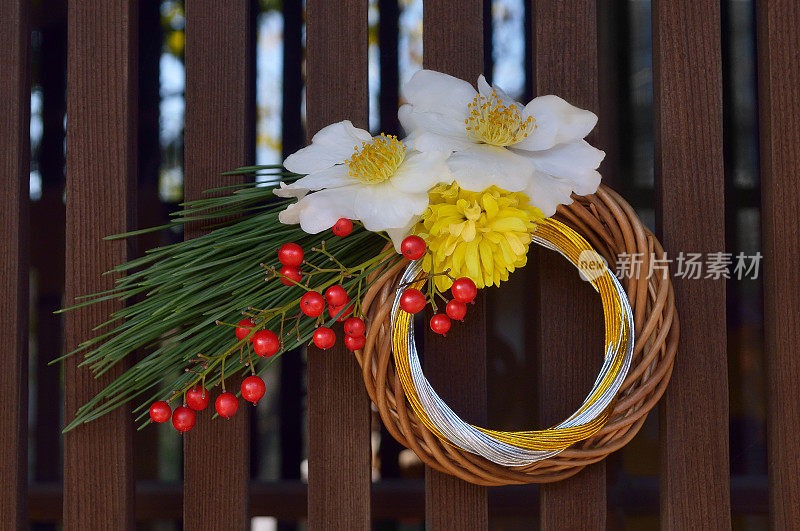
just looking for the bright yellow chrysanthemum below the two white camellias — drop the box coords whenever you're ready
[413,183,544,291]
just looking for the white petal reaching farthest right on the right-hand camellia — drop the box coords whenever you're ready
[515,140,606,195]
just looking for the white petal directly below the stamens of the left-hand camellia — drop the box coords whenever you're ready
[354,182,428,232]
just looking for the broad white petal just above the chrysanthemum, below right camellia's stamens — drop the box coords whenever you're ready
[447,144,534,192]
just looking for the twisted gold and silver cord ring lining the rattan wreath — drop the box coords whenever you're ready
[392,219,634,466]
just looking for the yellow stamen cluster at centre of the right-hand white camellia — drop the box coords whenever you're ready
[464,91,536,146]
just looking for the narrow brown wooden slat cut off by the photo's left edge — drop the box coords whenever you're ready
[0,0,31,529]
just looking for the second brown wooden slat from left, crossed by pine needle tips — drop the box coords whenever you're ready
[64,0,138,529]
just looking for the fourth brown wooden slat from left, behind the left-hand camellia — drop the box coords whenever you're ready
[306,0,371,530]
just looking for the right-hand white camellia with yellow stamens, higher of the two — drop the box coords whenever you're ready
[399,70,605,216]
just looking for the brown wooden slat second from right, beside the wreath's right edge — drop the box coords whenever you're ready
[652,0,731,529]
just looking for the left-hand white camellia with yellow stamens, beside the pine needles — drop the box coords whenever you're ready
[273,120,450,247]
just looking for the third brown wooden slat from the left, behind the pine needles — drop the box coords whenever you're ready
[183,0,255,529]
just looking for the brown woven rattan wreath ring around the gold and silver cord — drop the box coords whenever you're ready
[356,186,678,486]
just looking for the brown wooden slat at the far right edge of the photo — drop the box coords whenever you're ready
[757,0,800,529]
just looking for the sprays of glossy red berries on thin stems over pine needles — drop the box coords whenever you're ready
[145,218,478,433]
